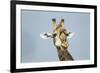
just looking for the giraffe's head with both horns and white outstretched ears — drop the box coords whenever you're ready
[40,18,74,48]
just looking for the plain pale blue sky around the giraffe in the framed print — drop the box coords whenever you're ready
[21,10,90,63]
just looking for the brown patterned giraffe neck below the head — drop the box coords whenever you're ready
[57,47,73,61]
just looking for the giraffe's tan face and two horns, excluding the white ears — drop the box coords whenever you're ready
[52,19,68,48]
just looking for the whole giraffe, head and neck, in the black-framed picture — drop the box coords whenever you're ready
[42,18,74,61]
